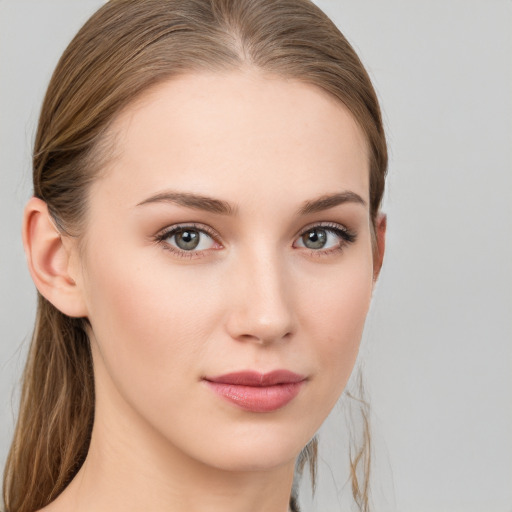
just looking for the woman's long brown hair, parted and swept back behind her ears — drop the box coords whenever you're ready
[4,0,387,512]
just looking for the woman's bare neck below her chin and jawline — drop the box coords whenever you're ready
[73,434,294,512]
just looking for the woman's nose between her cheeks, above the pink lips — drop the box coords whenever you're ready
[226,249,295,345]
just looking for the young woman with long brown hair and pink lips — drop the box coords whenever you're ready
[4,0,387,512]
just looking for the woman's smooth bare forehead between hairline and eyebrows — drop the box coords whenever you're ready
[95,72,369,210]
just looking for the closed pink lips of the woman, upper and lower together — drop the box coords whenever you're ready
[204,370,306,412]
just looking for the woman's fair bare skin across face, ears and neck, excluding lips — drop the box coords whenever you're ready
[24,70,385,512]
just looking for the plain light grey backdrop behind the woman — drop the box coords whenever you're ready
[0,0,512,512]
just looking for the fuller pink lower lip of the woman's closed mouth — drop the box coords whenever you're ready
[205,381,303,412]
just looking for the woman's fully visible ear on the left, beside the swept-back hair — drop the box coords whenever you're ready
[23,197,87,317]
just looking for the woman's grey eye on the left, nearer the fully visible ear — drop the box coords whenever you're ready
[157,225,220,257]
